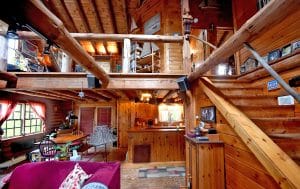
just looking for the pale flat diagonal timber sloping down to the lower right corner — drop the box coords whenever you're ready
[199,78,300,188]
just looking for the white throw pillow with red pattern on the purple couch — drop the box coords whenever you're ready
[59,163,91,189]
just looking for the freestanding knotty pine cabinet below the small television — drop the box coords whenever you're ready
[186,137,225,189]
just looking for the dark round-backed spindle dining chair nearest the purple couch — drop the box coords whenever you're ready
[39,137,57,161]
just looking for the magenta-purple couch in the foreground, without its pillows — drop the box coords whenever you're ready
[9,161,120,189]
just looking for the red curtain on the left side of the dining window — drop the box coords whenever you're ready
[0,100,17,135]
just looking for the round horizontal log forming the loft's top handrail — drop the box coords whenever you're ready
[0,31,183,43]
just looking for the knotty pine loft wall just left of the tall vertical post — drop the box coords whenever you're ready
[137,0,183,73]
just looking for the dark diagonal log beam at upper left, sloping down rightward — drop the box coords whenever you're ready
[1,0,109,87]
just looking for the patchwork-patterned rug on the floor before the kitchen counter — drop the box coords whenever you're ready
[138,166,185,178]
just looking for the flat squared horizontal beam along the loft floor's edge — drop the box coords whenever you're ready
[7,72,182,90]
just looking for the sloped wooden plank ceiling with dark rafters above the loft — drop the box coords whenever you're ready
[42,0,140,55]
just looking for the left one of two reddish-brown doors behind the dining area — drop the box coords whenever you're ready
[80,107,95,134]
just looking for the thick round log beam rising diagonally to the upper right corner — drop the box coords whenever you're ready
[188,0,300,82]
